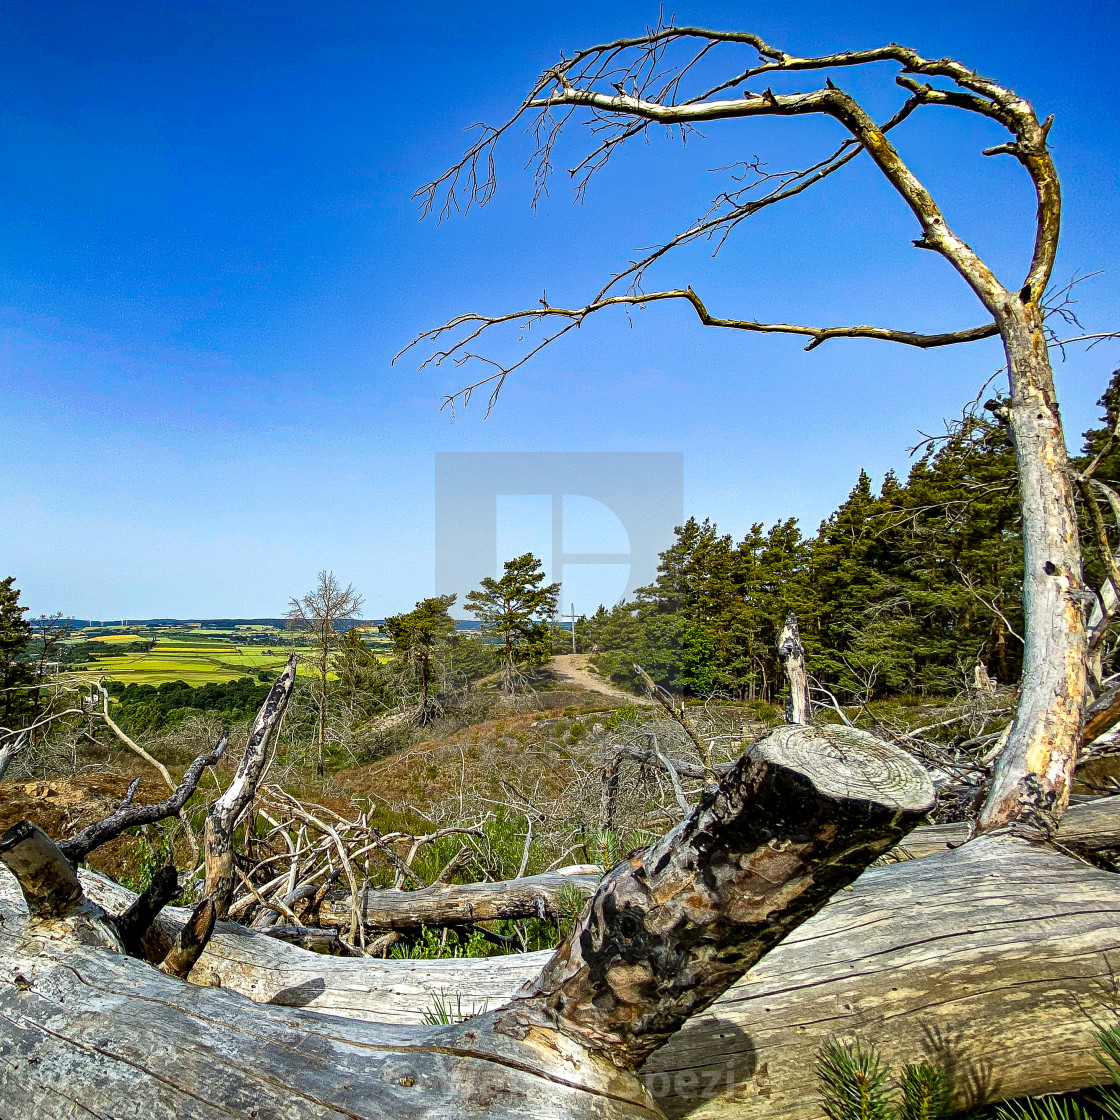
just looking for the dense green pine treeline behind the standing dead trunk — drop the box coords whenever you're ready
[579,371,1120,700]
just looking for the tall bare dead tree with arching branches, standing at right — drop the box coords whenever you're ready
[413,26,1091,830]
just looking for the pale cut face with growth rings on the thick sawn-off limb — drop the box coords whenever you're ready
[747,724,934,813]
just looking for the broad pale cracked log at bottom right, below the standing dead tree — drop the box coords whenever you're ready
[643,836,1120,1120]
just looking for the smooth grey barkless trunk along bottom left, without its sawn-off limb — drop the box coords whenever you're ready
[0,912,659,1120]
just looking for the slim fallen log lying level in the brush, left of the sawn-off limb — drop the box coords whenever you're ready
[319,868,599,930]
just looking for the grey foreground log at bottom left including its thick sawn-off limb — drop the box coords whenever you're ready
[0,728,932,1120]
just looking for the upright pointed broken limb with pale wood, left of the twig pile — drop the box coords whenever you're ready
[203,654,296,917]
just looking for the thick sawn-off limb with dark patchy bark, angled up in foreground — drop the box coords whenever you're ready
[496,726,933,1070]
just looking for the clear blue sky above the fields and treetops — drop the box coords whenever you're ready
[0,0,1120,617]
